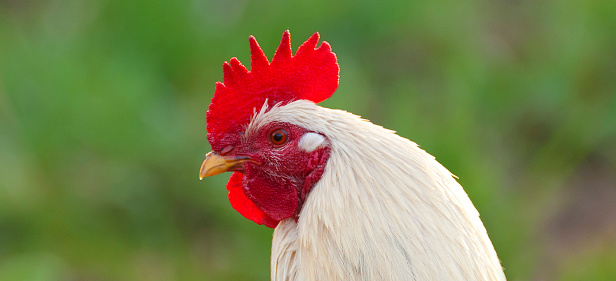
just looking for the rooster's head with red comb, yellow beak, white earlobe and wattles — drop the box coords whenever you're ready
[199,30,339,228]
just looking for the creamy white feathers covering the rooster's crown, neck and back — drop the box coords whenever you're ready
[246,100,505,281]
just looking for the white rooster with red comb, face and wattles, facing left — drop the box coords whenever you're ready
[199,30,505,281]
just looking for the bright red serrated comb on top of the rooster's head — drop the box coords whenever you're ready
[207,30,340,151]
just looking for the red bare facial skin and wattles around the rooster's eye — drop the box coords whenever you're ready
[223,123,330,227]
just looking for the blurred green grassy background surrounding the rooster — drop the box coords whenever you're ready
[0,0,616,281]
